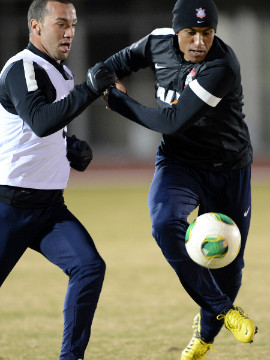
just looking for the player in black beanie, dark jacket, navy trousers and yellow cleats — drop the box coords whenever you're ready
[105,0,256,360]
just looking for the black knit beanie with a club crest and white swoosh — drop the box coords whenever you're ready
[172,0,218,33]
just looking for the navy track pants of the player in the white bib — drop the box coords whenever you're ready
[0,202,105,360]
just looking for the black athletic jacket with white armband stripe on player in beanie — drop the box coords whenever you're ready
[106,29,252,171]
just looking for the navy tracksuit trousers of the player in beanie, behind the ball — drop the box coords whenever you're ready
[149,150,251,342]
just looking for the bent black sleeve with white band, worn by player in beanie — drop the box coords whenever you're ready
[108,65,234,135]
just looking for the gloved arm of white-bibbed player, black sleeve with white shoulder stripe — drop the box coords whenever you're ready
[0,60,115,137]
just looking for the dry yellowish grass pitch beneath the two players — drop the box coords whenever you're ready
[0,184,270,360]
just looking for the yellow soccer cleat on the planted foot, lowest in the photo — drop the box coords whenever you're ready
[180,314,213,360]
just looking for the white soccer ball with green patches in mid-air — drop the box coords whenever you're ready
[185,212,241,269]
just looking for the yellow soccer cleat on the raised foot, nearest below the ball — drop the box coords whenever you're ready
[217,306,258,343]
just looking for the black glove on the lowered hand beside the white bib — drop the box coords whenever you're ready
[66,135,93,171]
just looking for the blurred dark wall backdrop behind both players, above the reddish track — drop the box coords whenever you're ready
[0,0,270,170]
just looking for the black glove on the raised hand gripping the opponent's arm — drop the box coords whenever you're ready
[86,62,117,95]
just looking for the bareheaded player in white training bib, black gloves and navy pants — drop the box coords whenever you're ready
[0,0,115,360]
